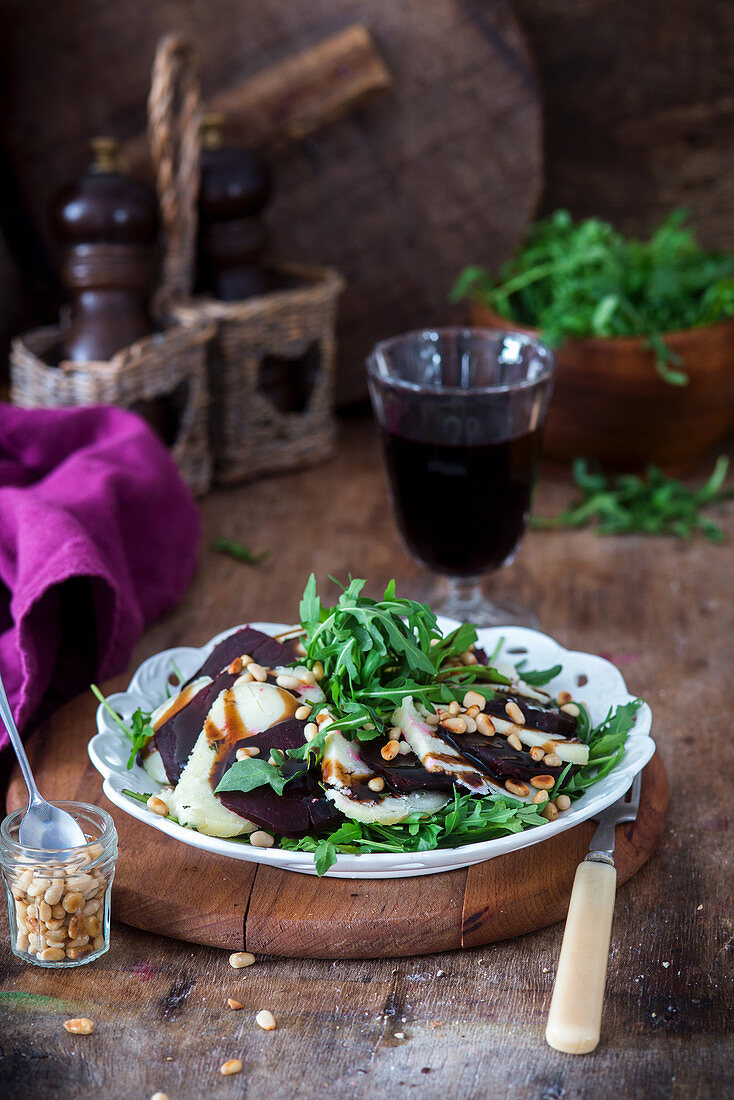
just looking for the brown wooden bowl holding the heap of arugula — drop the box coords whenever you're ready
[471,303,734,473]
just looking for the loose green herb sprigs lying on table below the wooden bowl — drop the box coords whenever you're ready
[533,455,734,542]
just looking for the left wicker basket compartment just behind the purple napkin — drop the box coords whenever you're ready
[10,325,215,493]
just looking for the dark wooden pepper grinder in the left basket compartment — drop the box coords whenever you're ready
[52,138,156,363]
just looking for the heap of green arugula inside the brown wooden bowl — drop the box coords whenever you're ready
[451,210,734,386]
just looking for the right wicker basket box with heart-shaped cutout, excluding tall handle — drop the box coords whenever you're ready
[173,265,343,484]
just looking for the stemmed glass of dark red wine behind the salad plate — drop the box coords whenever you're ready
[368,328,554,626]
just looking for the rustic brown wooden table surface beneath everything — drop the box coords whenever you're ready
[0,419,734,1100]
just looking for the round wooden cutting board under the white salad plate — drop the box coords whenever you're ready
[8,679,668,958]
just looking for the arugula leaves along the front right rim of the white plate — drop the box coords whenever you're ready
[281,699,642,875]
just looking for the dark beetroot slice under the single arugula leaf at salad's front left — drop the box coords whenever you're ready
[211,718,341,837]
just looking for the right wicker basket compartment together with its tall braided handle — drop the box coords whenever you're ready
[149,37,343,484]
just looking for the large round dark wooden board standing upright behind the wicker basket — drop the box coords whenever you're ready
[0,0,541,400]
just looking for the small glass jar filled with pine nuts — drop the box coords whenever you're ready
[0,802,118,967]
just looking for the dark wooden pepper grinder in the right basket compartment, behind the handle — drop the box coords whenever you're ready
[197,114,273,301]
